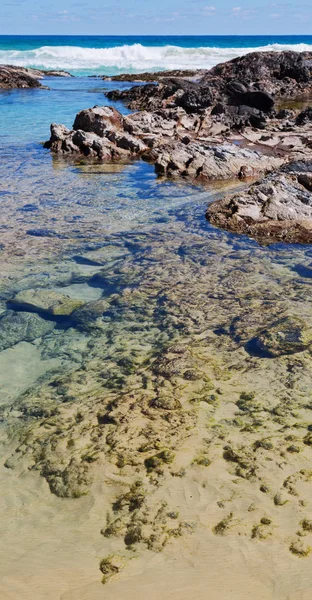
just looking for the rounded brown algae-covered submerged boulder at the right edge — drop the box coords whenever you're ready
[252,317,312,357]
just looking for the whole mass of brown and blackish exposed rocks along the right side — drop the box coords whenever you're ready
[45,52,312,242]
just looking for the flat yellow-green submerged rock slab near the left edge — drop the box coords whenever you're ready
[11,289,84,316]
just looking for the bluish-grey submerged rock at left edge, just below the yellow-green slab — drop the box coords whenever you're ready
[0,310,55,352]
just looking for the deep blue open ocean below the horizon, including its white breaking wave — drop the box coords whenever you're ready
[0,35,312,75]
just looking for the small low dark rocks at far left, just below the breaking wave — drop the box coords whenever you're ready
[0,65,71,90]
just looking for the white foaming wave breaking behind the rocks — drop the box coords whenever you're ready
[0,44,312,74]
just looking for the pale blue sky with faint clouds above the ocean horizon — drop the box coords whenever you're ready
[0,0,312,35]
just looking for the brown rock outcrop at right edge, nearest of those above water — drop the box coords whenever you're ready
[206,162,312,243]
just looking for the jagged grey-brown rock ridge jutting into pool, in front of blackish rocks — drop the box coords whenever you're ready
[45,107,282,180]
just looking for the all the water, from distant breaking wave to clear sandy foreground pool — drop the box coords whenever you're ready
[0,36,312,600]
